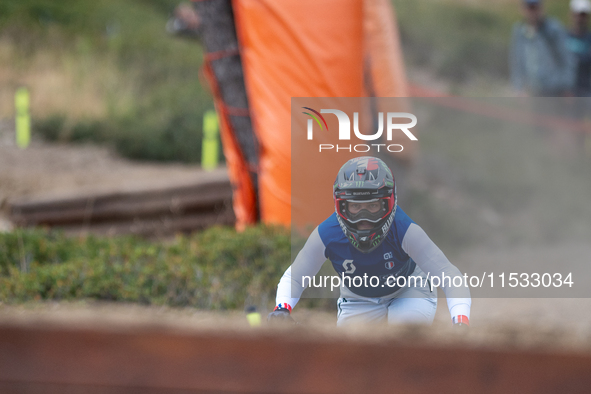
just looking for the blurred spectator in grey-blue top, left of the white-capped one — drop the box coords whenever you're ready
[510,0,574,97]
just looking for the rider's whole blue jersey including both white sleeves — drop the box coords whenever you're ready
[276,207,471,317]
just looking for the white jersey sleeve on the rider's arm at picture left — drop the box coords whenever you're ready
[276,227,326,308]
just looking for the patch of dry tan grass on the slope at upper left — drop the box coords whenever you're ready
[0,39,135,121]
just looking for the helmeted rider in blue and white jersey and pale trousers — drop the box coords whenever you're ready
[269,156,471,326]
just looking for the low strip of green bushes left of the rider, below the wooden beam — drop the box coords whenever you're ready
[0,226,290,309]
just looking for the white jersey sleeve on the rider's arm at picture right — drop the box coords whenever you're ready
[402,223,472,318]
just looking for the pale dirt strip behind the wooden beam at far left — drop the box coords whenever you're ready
[0,119,217,231]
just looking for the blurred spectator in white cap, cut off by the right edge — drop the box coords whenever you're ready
[567,0,591,97]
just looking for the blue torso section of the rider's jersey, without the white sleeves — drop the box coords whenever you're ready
[318,208,416,297]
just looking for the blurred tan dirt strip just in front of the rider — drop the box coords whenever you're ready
[0,299,591,354]
